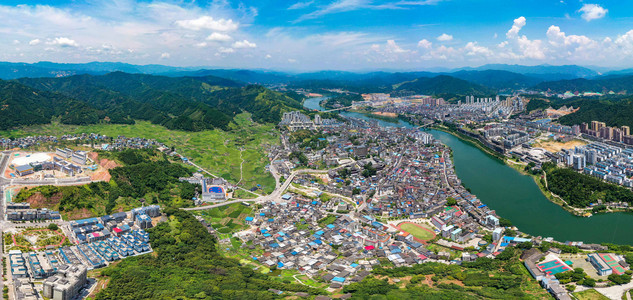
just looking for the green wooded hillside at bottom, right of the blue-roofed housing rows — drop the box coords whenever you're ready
[96,209,320,300]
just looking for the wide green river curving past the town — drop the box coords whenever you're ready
[304,98,633,245]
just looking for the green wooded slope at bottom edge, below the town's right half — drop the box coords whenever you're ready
[343,247,547,299]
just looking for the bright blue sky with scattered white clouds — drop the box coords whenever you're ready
[0,0,633,71]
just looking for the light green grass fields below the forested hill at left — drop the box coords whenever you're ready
[0,113,279,193]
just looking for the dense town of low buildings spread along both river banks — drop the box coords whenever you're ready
[3,96,631,299]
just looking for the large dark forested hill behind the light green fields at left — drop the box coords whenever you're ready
[11,72,302,131]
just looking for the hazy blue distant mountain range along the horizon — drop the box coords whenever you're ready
[0,62,633,94]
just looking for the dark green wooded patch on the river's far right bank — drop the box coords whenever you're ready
[543,164,633,207]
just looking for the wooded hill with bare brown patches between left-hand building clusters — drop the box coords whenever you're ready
[13,150,196,219]
